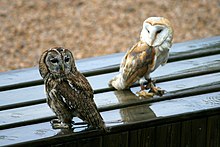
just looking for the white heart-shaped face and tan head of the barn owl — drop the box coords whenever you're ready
[140,17,173,47]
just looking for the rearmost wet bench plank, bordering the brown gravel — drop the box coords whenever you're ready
[0,36,220,91]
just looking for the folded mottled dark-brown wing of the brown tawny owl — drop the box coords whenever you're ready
[58,73,104,128]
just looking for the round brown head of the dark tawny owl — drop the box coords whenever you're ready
[39,47,76,78]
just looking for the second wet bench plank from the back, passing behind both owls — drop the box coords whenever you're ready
[0,55,220,110]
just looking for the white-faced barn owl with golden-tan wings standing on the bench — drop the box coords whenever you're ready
[109,17,173,96]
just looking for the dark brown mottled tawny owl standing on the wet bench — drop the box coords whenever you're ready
[39,47,106,130]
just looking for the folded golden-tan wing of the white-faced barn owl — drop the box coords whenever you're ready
[120,41,155,86]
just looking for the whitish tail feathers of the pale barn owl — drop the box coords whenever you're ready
[109,74,128,90]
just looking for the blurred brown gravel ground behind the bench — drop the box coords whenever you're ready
[0,0,220,72]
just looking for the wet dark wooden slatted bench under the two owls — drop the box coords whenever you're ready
[0,36,220,147]
